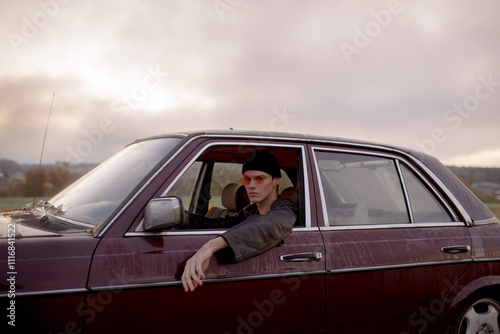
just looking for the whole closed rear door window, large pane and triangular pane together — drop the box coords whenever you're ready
[315,151,453,226]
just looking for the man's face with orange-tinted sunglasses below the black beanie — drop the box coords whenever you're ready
[243,170,280,203]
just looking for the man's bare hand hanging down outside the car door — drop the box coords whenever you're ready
[181,237,229,292]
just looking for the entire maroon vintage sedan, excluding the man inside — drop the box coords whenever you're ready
[0,131,500,333]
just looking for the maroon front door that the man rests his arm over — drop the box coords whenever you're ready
[84,140,326,333]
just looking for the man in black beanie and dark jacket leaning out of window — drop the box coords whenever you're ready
[181,151,297,292]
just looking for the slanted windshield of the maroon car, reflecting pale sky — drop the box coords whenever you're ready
[49,138,180,225]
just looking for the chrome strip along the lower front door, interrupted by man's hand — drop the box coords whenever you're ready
[89,270,326,292]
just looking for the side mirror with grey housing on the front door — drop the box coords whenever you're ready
[144,197,184,231]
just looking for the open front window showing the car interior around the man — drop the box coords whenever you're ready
[165,145,303,225]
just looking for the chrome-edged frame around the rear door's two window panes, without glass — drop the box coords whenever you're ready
[311,146,464,230]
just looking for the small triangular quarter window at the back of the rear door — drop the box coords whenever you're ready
[401,165,452,223]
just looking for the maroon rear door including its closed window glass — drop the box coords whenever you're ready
[312,146,470,333]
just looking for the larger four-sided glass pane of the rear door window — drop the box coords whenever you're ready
[316,151,409,226]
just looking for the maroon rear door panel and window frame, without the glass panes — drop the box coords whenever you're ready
[309,144,472,333]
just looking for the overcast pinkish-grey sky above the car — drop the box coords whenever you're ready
[0,0,500,167]
